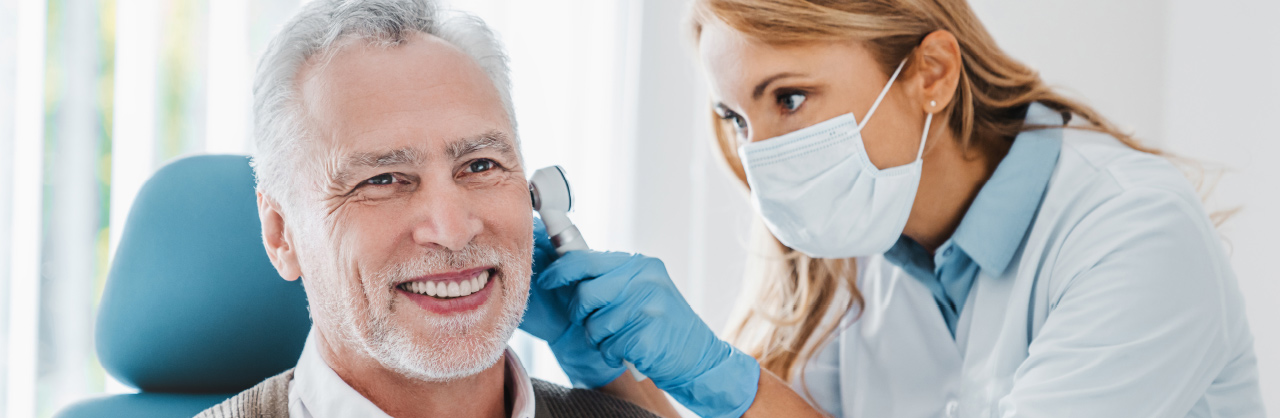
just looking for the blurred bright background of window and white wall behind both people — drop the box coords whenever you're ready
[0,0,1280,417]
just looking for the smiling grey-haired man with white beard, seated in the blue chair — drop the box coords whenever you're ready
[193,0,670,418]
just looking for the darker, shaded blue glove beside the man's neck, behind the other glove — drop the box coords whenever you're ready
[520,217,626,387]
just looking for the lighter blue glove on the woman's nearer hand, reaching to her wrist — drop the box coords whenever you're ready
[539,251,760,417]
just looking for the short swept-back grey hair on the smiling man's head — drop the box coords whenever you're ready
[253,0,518,199]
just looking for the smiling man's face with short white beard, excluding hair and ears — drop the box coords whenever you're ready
[288,35,532,381]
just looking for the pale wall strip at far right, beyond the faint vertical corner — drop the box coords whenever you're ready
[1162,0,1280,415]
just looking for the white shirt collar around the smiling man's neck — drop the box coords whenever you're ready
[289,327,534,418]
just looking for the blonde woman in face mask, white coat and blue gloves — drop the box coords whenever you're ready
[522,0,1265,417]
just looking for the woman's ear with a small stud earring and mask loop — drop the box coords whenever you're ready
[911,31,964,114]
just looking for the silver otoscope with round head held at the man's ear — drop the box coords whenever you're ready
[529,165,646,382]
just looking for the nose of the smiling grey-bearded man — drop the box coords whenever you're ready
[413,182,484,251]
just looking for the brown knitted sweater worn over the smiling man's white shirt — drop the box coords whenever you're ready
[196,368,658,418]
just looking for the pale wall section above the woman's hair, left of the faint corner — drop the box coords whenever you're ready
[970,0,1167,142]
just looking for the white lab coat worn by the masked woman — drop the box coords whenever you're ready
[809,105,1265,418]
